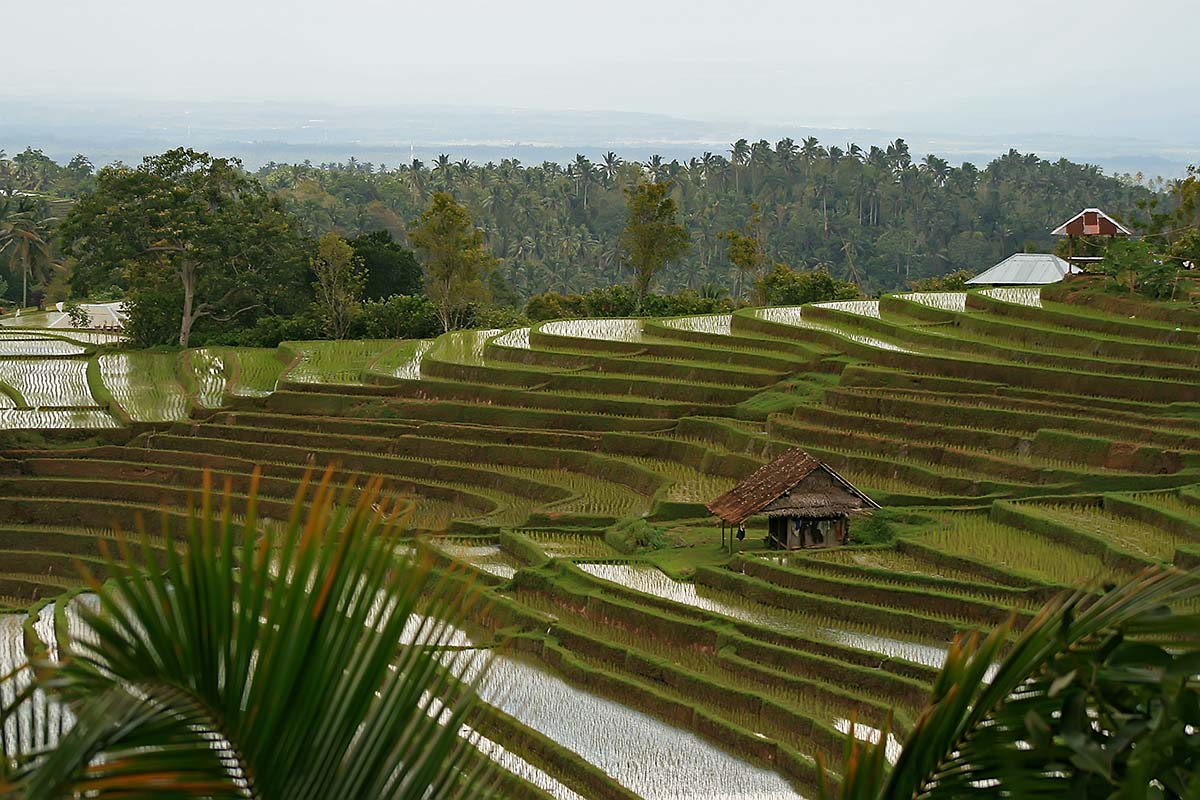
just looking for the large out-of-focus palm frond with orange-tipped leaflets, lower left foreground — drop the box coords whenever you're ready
[0,473,494,800]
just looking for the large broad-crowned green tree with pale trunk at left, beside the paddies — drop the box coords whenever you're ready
[61,149,307,347]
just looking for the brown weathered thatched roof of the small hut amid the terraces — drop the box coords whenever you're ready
[708,447,880,525]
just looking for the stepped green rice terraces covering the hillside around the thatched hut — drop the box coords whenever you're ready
[7,287,1200,800]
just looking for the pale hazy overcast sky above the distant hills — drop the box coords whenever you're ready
[0,0,1200,140]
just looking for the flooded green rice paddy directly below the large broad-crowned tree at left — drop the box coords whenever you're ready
[98,353,188,422]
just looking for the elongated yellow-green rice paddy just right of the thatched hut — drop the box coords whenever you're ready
[918,513,1127,585]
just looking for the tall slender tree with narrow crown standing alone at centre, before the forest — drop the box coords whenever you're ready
[620,182,690,309]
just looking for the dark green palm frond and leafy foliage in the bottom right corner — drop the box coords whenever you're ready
[822,567,1200,800]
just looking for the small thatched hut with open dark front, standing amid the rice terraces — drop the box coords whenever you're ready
[708,447,880,549]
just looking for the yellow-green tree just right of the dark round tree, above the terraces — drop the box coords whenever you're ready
[408,192,496,331]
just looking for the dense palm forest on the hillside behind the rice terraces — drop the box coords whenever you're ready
[250,139,1156,299]
